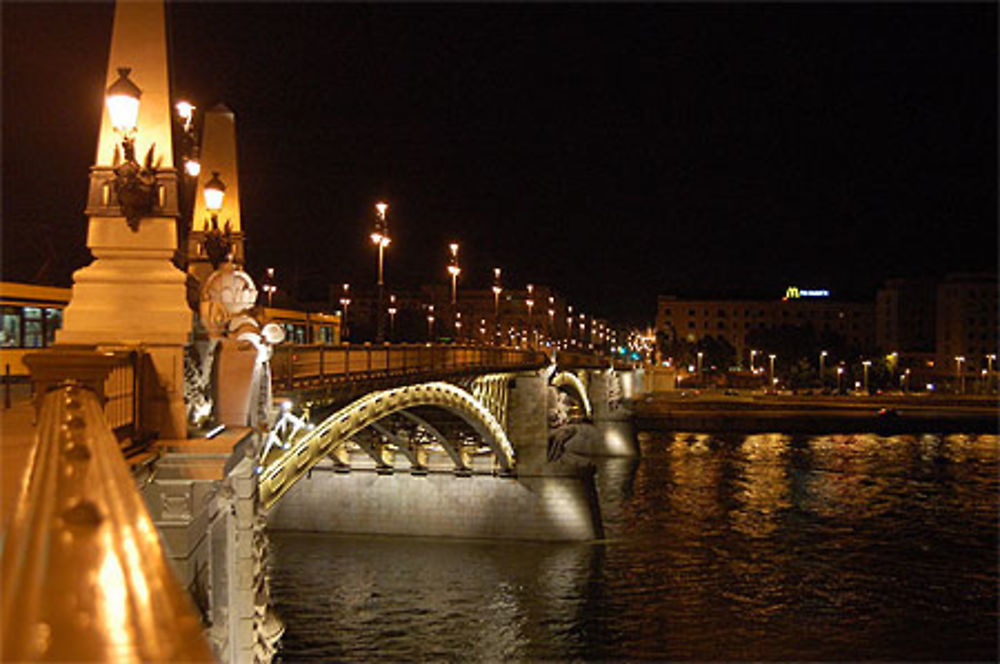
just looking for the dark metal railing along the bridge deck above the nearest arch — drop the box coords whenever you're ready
[271,344,548,389]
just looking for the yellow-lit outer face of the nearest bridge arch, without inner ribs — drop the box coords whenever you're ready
[259,382,515,507]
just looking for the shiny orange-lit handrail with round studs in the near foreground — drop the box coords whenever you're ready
[0,383,213,662]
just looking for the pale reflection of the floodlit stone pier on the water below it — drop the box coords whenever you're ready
[271,533,598,661]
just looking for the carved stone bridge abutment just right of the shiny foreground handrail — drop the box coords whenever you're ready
[143,429,282,664]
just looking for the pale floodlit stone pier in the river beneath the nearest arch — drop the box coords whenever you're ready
[268,372,603,541]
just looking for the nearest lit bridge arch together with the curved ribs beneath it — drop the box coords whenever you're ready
[260,382,515,507]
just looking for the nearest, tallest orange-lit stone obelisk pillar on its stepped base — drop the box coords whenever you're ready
[56,2,191,437]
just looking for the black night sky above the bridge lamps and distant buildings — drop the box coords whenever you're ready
[2,3,998,322]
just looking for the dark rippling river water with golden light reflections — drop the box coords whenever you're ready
[269,434,1000,662]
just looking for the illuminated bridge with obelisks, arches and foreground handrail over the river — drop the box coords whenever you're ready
[2,2,644,662]
